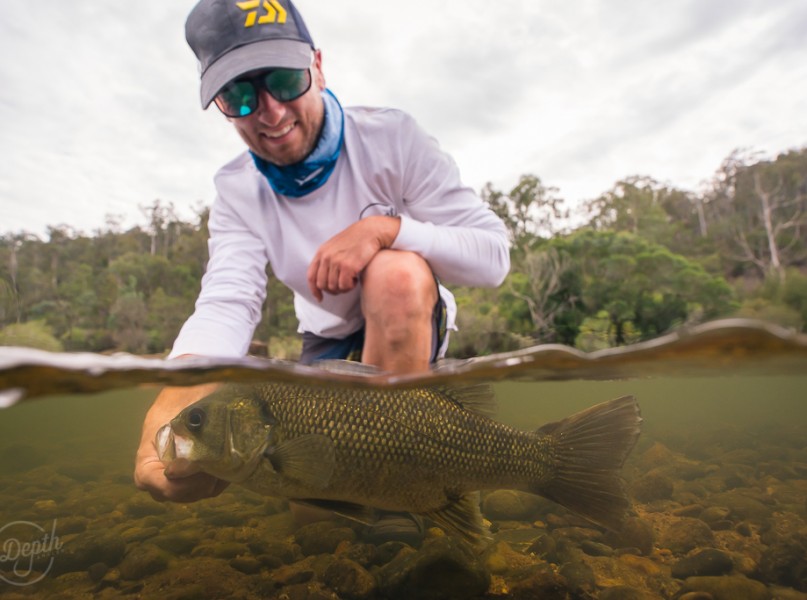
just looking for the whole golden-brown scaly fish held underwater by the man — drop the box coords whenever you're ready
[155,382,642,544]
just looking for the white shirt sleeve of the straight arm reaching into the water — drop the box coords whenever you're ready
[169,190,268,358]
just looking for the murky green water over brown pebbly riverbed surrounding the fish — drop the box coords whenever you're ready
[0,318,807,599]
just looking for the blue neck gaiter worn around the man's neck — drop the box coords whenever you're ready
[249,89,345,198]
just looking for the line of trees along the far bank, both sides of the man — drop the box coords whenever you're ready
[0,149,807,358]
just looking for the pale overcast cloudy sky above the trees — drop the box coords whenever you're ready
[0,0,807,239]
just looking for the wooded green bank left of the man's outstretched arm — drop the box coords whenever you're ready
[0,202,207,352]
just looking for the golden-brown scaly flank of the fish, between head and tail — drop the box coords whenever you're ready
[263,386,549,502]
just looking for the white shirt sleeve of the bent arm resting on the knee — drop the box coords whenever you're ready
[392,117,510,287]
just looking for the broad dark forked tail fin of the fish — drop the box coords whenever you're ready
[529,396,642,530]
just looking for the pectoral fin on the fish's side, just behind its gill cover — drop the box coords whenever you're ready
[263,434,336,489]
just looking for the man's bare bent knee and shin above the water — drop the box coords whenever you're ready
[362,250,437,373]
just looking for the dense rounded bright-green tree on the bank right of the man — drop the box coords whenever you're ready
[516,229,735,345]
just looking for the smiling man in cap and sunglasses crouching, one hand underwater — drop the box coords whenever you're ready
[135,0,509,516]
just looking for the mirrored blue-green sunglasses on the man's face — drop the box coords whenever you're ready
[215,69,311,119]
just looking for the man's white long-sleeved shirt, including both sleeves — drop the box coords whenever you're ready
[171,107,510,357]
